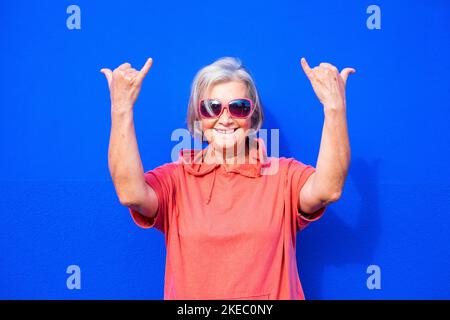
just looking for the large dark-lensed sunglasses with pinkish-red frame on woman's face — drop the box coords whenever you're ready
[198,98,254,119]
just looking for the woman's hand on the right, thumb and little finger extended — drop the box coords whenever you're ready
[301,58,356,112]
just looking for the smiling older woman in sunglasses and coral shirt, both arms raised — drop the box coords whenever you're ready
[101,58,355,299]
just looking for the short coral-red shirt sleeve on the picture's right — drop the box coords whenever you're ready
[287,159,326,231]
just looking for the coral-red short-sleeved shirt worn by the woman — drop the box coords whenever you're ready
[130,140,326,299]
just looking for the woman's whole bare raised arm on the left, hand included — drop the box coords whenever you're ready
[101,59,158,217]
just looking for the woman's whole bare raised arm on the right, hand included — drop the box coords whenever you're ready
[299,58,355,213]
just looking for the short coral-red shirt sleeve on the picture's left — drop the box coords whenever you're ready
[129,163,177,234]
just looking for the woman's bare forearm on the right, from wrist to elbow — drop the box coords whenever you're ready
[312,106,350,202]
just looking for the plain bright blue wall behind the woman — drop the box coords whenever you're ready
[0,0,450,299]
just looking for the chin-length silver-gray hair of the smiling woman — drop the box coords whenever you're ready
[187,57,264,137]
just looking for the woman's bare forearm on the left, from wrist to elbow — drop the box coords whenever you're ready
[108,108,146,204]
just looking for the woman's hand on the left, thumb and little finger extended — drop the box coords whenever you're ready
[100,58,153,111]
